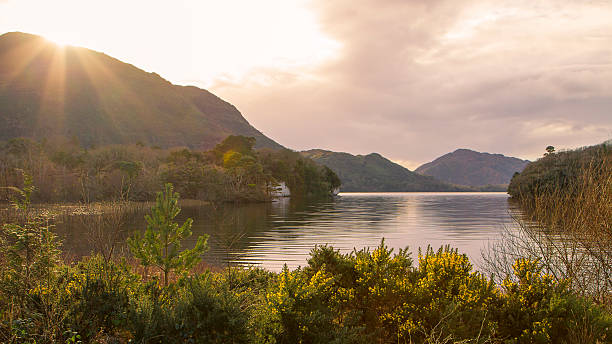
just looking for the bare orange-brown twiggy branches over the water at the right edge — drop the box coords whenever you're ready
[483,157,612,304]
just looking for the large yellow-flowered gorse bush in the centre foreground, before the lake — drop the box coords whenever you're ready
[268,242,496,343]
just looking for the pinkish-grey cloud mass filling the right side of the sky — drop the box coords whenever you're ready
[212,0,612,165]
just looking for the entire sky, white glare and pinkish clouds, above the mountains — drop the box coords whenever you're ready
[0,0,612,169]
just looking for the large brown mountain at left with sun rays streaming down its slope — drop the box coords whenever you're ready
[0,32,282,149]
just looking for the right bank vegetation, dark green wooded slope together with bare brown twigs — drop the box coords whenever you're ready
[488,144,612,305]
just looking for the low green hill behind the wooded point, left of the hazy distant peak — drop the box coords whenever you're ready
[301,149,467,192]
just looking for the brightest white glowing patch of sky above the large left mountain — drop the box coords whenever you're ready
[0,0,340,87]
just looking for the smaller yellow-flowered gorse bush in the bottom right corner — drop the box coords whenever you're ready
[494,259,612,343]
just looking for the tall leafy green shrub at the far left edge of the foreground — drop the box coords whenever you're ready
[0,173,64,342]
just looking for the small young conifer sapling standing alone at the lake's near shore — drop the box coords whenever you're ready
[128,183,208,286]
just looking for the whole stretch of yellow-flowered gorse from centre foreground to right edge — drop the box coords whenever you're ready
[266,242,612,343]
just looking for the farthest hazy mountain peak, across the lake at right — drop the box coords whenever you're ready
[415,149,529,186]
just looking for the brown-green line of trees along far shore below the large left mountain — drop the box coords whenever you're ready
[0,136,340,202]
